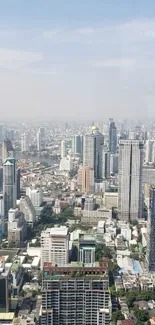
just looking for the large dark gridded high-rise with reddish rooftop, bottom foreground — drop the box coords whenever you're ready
[42,262,111,325]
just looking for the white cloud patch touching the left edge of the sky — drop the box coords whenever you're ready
[0,48,43,70]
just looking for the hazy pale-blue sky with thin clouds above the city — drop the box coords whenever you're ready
[0,0,155,121]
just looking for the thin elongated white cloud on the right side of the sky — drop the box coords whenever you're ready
[93,59,136,68]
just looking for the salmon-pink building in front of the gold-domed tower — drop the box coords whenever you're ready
[78,166,94,193]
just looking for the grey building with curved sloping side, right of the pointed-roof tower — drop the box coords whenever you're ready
[20,196,36,227]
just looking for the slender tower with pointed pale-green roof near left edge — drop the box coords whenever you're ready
[3,158,17,219]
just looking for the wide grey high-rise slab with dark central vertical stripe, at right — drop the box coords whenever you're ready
[118,140,143,220]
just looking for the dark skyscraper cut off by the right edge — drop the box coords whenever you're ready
[146,186,155,272]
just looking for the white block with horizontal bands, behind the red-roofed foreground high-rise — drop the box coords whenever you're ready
[41,226,69,267]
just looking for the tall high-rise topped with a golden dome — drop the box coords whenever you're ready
[83,126,104,179]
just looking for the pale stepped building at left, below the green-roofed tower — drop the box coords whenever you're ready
[8,209,27,243]
